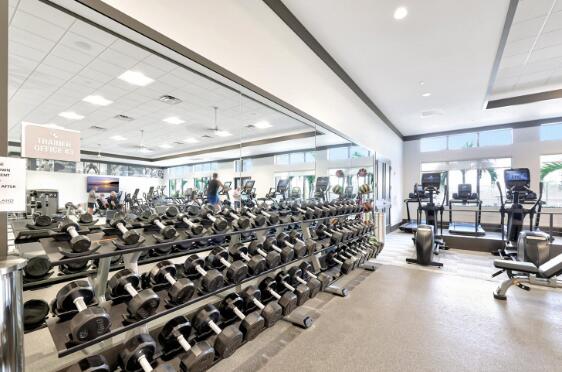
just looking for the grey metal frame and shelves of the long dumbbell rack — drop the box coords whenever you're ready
[16,213,376,369]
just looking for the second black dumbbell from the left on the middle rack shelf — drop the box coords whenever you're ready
[107,269,160,319]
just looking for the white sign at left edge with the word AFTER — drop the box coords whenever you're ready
[0,157,26,212]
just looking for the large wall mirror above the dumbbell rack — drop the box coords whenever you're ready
[9,0,384,221]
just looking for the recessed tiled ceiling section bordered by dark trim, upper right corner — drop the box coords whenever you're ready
[491,0,562,102]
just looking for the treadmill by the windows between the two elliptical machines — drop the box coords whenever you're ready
[449,183,486,236]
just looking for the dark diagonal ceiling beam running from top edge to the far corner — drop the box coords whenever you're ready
[263,0,403,138]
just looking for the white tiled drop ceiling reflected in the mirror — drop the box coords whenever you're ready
[8,0,326,158]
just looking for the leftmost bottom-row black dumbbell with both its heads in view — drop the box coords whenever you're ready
[158,315,215,372]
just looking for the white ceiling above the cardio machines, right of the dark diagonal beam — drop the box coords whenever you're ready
[283,0,562,135]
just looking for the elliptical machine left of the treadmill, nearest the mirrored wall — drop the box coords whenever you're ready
[406,173,449,268]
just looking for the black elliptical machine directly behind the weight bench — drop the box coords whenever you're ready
[497,168,551,265]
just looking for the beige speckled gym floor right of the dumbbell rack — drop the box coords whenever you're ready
[212,232,562,372]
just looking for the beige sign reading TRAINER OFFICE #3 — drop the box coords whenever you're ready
[21,122,80,162]
